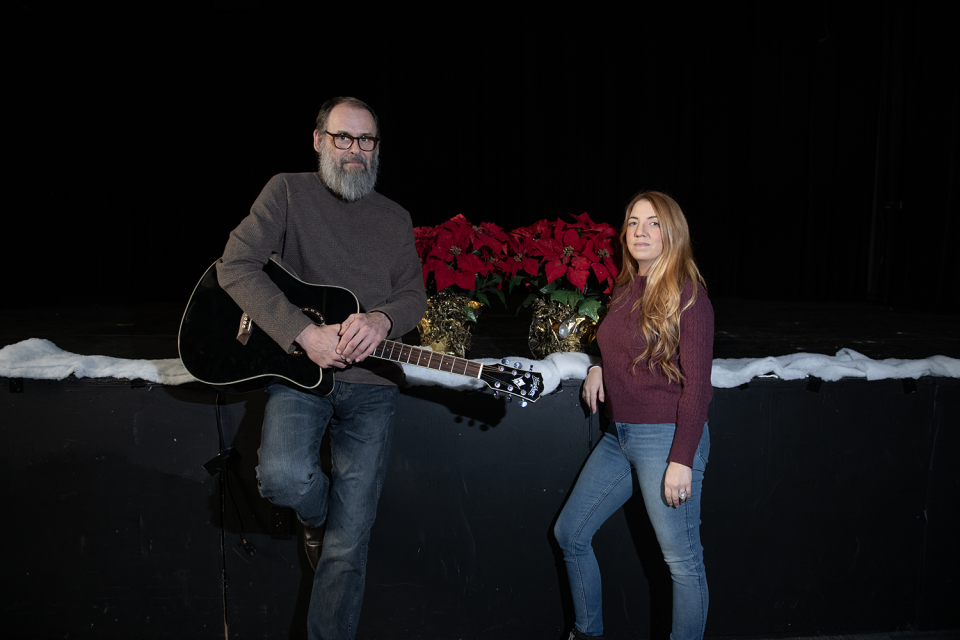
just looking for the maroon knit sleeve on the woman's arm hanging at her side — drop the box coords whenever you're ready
[669,285,713,467]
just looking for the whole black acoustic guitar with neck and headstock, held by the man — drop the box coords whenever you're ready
[179,259,543,406]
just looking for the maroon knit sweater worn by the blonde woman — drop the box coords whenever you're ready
[597,276,713,467]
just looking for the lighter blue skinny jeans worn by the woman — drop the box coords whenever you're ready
[554,422,710,640]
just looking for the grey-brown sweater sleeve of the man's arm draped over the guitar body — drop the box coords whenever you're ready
[217,175,310,353]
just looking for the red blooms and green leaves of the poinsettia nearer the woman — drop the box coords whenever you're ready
[500,213,619,320]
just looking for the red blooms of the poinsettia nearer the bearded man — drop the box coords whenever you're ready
[413,214,508,322]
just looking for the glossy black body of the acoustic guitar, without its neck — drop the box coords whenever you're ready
[178,259,360,395]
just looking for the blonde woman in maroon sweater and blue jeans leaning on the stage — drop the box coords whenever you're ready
[554,191,713,640]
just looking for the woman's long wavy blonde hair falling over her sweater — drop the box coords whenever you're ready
[614,191,706,382]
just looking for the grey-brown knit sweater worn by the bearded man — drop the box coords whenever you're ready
[217,173,427,384]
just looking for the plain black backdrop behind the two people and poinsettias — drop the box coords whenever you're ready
[0,0,960,311]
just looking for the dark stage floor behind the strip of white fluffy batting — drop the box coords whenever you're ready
[0,298,960,360]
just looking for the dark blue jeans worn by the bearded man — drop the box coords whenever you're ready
[257,381,399,640]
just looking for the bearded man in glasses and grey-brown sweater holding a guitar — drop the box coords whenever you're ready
[217,98,427,640]
